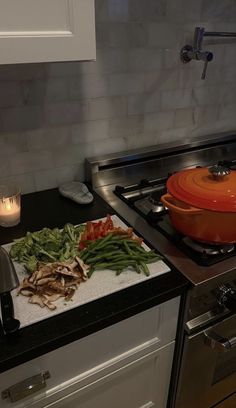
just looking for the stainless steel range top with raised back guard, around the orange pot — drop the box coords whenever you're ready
[86,134,236,292]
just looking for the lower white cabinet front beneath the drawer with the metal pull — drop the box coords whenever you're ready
[39,342,174,408]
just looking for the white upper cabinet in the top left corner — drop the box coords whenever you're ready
[0,0,96,64]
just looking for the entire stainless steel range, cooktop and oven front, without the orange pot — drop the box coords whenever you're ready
[87,134,236,408]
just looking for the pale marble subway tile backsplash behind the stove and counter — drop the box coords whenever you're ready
[0,0,236,192]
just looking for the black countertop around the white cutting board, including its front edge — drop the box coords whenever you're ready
[0,189,189,372]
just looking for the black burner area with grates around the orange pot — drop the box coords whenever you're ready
[114,176,236,266]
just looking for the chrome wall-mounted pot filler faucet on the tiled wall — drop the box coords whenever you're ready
[180,27,236,79]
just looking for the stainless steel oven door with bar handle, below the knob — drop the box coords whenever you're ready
[175,315,236,408]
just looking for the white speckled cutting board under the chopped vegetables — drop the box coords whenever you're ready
[1,215,170,328]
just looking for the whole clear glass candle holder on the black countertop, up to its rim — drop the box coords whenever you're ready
[0,183,21,227]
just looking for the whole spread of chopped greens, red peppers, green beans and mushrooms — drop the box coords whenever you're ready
[10,215,161,310]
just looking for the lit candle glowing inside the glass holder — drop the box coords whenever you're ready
[0,186,21,227]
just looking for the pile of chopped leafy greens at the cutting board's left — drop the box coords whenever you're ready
[10,224,84,273]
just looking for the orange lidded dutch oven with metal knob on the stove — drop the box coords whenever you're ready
[161,166,236,244]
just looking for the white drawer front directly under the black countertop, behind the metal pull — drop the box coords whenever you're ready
[0,298,179,408]
